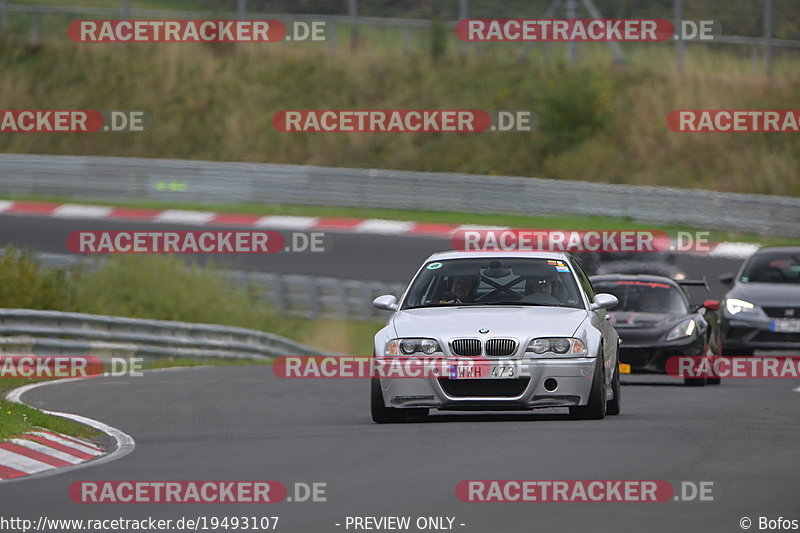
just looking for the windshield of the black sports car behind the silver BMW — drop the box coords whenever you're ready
[592,280,689,314]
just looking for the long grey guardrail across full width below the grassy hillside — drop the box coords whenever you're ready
[0,154,800,235]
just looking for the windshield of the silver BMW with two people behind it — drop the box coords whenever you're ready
[403,258,584,309]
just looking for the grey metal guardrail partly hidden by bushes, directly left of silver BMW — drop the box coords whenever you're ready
[31,250,406,321]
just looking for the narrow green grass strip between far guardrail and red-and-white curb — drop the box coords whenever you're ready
[2,195,800,246]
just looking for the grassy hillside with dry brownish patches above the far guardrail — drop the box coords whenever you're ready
[0,37,800,195]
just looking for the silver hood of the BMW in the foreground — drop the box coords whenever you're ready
[392,306,588,339]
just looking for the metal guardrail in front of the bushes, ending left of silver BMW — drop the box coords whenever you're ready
[0,309,327,359]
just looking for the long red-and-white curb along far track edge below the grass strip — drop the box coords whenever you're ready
[0,200,758,259]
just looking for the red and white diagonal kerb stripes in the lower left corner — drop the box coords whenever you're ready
[0,429,104,480]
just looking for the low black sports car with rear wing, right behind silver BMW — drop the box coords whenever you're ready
[591,274,720,385]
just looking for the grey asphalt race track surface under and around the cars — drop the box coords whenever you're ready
[0,212,800,533]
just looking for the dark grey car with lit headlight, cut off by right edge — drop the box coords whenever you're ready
[720,247,800,356]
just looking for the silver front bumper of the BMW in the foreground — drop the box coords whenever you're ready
[380,357,596,410]
